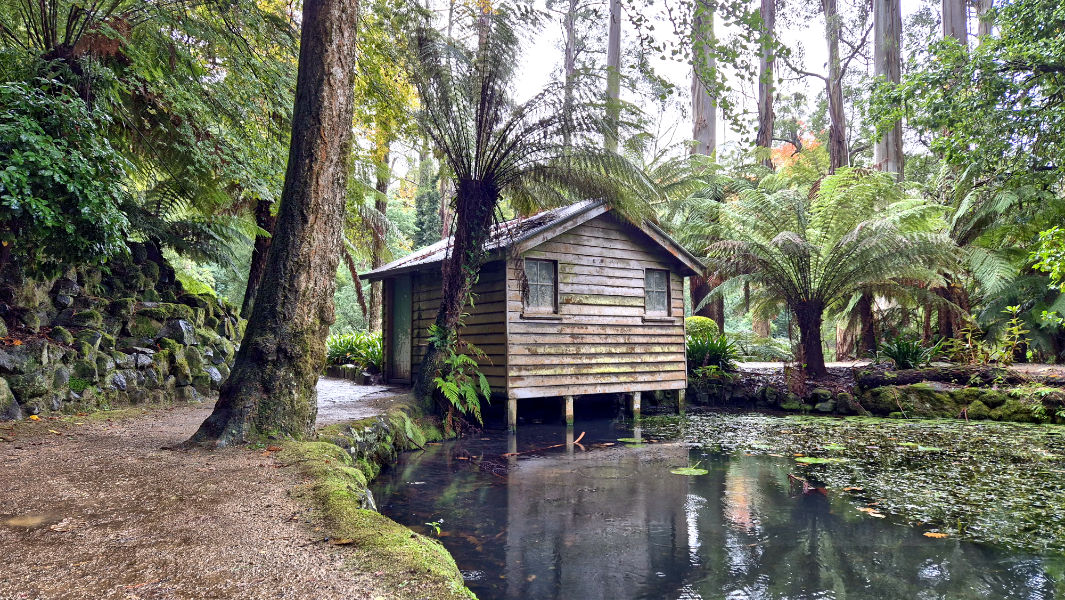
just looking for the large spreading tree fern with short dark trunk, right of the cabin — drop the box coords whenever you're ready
[692,168,953,374]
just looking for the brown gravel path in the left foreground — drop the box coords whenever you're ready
[0,379,406,600]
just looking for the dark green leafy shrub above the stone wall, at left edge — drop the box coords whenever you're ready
[0,79,129,275]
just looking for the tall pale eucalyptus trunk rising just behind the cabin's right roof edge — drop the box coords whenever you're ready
[688,0,725,331]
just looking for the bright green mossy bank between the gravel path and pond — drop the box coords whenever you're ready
[278,407,474,599]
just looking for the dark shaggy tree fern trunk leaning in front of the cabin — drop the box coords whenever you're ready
[413,180,499,405]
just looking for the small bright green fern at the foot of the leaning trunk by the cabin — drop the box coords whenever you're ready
[429,323,492,428]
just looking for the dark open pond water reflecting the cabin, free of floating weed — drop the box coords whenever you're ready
[373,419,1065,600]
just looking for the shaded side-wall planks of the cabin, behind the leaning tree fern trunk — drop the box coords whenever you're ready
[411,261,507,393]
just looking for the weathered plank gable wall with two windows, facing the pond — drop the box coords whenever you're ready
[506,214,687,399]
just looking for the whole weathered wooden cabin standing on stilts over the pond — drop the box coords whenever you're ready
[365,201,701,426]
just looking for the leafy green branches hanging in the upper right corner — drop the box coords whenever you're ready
[873,0,1065,185]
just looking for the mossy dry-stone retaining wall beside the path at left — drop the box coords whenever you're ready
[0,244,244,420]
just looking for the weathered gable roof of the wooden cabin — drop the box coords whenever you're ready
[362,200,703,281]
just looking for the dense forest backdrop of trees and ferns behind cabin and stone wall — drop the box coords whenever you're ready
[0,0,1065,398]
